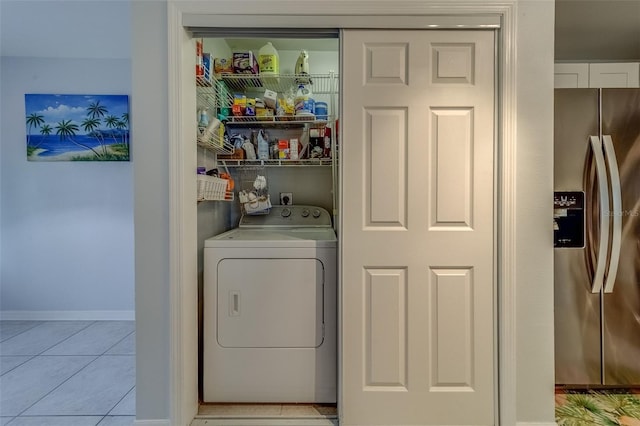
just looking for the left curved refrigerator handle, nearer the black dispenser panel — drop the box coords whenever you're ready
[589,136,609,293]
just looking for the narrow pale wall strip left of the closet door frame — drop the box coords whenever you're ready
[131,1,171,426]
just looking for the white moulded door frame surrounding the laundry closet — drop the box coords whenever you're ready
[167,0,517,425]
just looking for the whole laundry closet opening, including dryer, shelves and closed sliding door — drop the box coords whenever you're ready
[186,24,497,425]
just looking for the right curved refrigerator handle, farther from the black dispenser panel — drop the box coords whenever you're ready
[602,135,622,293]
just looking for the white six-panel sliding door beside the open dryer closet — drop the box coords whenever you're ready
[341,30,496,425]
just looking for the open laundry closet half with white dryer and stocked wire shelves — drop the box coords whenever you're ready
[194,31,340,424]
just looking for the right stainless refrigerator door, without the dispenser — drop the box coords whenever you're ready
[602,89,640,386]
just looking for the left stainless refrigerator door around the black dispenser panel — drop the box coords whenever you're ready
[554,89,602,385]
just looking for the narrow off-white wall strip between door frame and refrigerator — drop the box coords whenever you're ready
[516,0,555,423]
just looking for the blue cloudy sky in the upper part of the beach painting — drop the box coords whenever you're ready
[25,94,129,135]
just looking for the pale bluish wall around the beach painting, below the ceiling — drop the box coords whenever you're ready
[0,57,135,319]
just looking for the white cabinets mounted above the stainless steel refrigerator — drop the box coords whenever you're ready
[554,62,640,89]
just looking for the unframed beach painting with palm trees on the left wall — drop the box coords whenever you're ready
[24,94,130,161]
